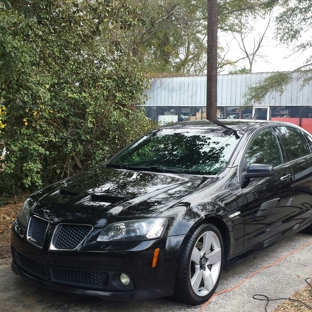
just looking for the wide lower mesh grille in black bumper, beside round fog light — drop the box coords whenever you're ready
[52,268,108,289]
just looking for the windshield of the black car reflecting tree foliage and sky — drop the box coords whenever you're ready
[108,128,238,174]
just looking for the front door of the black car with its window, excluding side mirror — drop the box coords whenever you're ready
[241,127,293,250]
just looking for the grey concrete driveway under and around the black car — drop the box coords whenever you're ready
[0,233,312,312]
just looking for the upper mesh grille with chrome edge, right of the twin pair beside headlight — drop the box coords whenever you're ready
[50,224,92,250]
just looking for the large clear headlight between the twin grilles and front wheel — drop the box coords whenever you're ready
[97,218,167,242]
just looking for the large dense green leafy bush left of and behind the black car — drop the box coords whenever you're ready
[0,0,154,196]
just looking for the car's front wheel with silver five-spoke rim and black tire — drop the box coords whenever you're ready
[174,223,224,305]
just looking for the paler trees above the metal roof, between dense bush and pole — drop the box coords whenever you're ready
[120,0,207,74]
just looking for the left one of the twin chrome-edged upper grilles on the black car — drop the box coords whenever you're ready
[27,216,49,248]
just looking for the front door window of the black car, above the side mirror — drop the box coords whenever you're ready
[245,128,282,167]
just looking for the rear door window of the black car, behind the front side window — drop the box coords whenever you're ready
[277,127,311,160]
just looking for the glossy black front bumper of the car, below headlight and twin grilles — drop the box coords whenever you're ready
[11,229,182,300]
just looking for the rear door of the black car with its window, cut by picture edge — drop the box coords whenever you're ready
[277,126,312,230]
